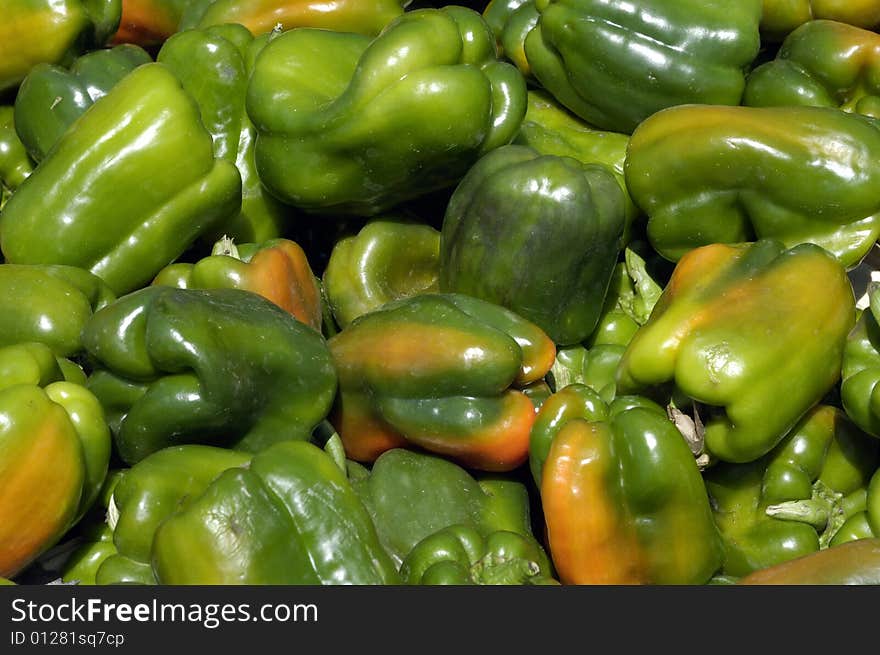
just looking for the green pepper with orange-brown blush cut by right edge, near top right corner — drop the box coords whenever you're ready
[743,20,880,118]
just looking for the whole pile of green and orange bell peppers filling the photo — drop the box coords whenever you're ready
[0,0,880,585]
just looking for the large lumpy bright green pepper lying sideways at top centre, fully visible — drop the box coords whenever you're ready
[247,6,526,216]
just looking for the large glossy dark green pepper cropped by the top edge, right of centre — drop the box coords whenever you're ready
[525,0,761,134]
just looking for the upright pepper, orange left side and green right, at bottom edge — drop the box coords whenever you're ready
[540,385,723,585]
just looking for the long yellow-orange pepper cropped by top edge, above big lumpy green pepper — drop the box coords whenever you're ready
[179,0,411,36]
